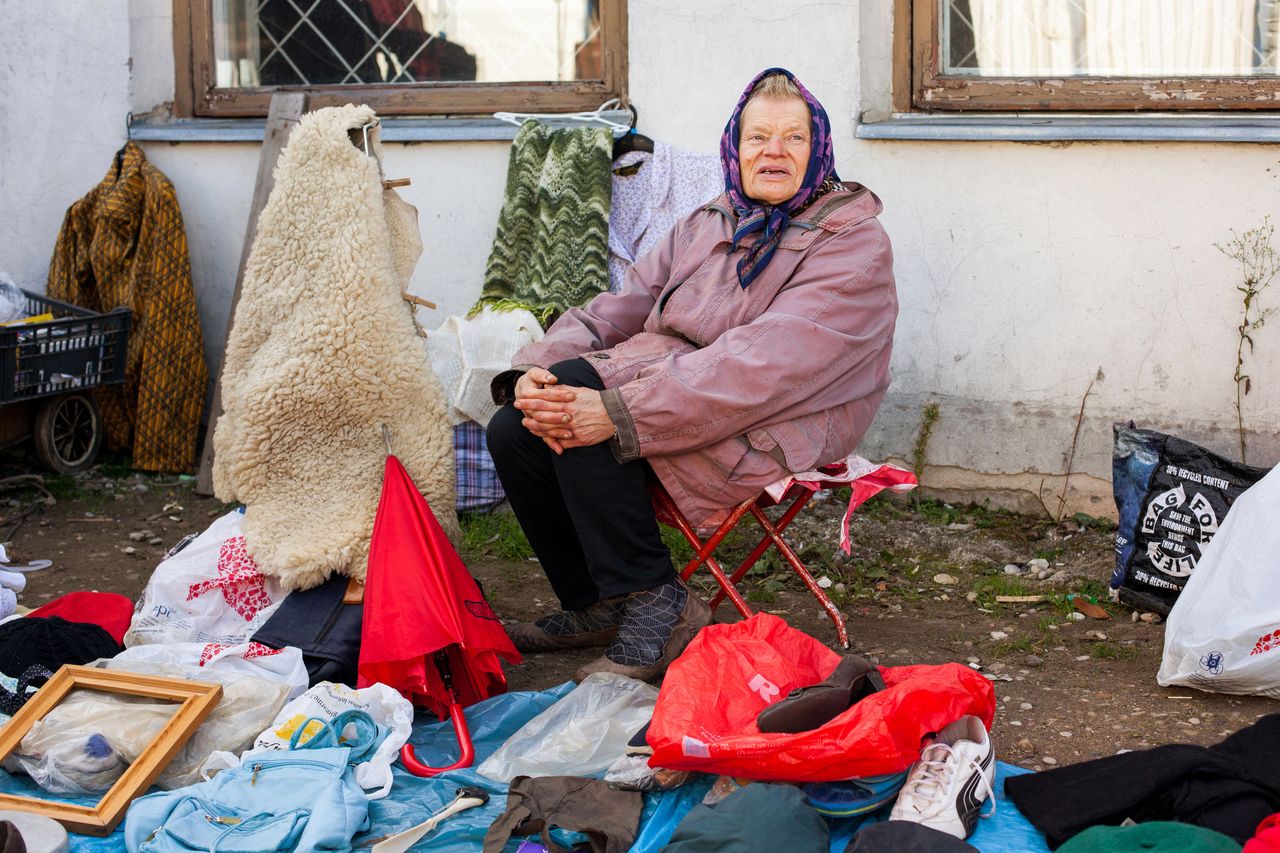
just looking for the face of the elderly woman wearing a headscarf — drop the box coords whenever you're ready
[737,97,812,205]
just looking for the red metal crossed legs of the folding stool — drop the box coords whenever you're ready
[649,483,849,648]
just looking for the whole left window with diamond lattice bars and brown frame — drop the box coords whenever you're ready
[175,0,626,115]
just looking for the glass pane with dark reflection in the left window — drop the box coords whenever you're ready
[214,0,604,88]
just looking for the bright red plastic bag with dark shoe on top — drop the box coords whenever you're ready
[649,613,996,781]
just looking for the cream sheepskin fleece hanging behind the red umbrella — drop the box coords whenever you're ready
[214,105,458,589]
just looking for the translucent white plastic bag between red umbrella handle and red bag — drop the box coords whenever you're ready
[476,672,658,783]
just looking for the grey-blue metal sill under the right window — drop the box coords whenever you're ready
[856,113,1280,142]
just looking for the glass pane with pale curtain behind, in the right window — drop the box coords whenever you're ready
[937,0,1280,77]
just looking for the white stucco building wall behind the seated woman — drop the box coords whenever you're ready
[0,0,1280,515]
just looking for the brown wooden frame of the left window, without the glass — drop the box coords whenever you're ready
[173,0,627,118]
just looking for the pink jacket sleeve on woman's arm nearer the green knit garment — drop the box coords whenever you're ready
[511,220,684,370]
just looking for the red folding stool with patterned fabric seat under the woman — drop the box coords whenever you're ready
[650,456,916,648]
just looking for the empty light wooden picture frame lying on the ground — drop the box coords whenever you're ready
[0,665,223,835]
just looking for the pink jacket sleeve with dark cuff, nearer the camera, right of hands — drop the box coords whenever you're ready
[604,220,897,460]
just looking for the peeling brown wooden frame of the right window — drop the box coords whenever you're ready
[893,0,1280,113]
